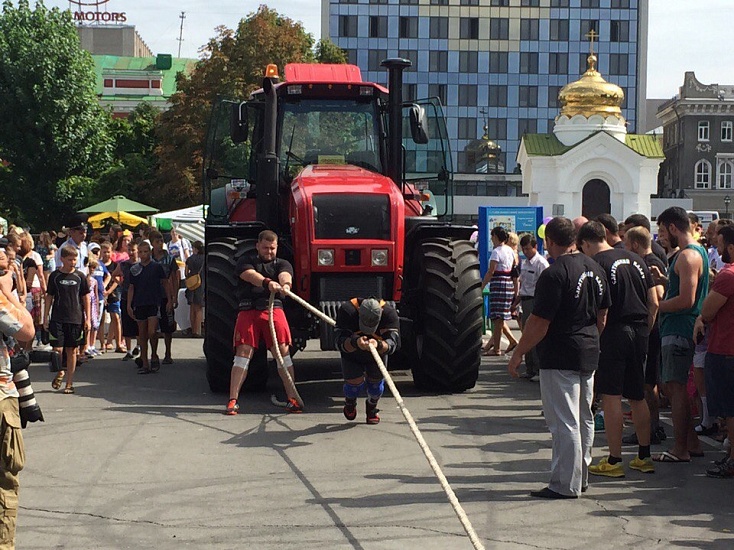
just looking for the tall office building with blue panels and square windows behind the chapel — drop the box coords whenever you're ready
[322,0,647,180]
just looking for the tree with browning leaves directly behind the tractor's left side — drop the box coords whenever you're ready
[157,6,345,207]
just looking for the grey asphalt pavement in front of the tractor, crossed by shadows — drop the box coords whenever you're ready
[12,339,734,550]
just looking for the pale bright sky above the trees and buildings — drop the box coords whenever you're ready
[31,0,734,98]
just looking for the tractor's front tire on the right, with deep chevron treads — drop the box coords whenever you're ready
[403,238,483,392]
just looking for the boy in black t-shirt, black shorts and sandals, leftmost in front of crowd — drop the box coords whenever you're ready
[43,245,92,394]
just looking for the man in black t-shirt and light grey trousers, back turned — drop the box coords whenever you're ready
[507,218,611,498]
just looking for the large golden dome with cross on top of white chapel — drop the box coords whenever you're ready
[558,53,624,118]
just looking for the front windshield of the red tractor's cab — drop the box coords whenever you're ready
[280,99,382,176]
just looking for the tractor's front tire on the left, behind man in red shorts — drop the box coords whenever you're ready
[204,237,268,393]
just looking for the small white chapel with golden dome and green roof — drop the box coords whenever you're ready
[517,45,664,220]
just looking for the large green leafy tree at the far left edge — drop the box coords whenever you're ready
[0,0,112,229]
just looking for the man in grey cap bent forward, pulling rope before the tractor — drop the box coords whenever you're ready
[334,298,400,424]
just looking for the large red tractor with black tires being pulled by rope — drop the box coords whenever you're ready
[204,59,482,392]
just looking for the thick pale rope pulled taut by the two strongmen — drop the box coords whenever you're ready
[278,290,484,550]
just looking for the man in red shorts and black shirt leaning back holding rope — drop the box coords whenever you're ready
[226,230,303,415]
